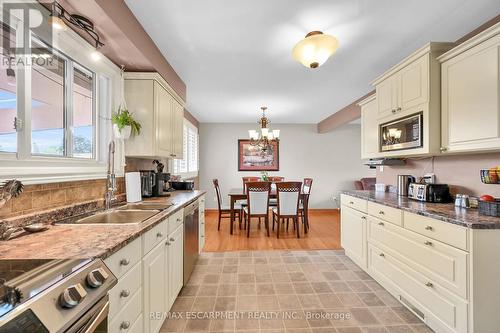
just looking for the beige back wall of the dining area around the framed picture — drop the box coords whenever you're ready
[200,123,375,208]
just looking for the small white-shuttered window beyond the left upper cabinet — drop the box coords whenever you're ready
[172,120,198,177]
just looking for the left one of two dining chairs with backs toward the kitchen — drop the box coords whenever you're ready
[243,182,271,237]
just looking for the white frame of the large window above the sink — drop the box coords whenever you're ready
[0,1,125,184]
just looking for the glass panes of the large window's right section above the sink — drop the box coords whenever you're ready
[31,41,95,158]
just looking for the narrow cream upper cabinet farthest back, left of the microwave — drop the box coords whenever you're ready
[358,95,380,159]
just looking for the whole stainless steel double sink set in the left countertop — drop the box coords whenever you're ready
[64,202,173,224]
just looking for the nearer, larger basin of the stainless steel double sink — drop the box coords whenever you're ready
[74,209,160,224]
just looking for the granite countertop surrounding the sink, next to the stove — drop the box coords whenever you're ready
[0,191,205,260]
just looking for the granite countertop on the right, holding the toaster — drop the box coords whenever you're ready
[342,190,500,229]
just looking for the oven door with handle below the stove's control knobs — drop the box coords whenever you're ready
[65,296,109,333]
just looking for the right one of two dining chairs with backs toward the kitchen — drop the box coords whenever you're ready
[273,182,302,238]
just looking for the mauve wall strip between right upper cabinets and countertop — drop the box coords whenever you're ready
[377,153,500,197]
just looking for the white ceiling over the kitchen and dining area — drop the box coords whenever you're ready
[125,0,500,123]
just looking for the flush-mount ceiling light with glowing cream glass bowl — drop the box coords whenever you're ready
[292,31,339,68]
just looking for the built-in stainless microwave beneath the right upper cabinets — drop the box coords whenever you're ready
[379,112,424,152]
